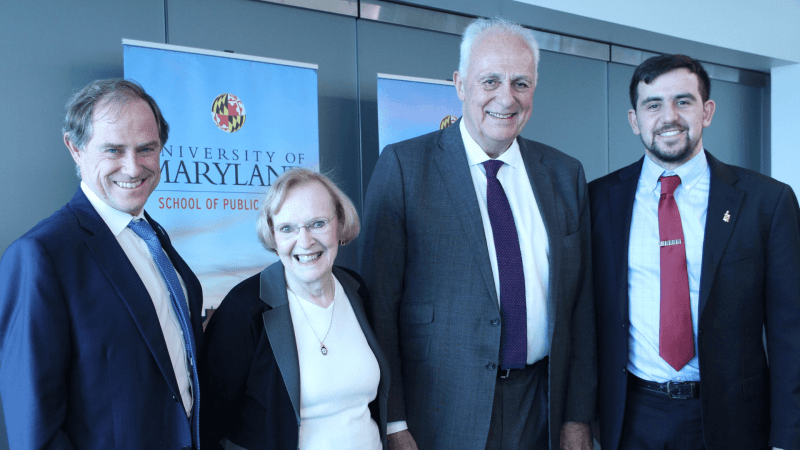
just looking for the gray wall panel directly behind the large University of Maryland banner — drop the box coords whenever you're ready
[167,0,361,270]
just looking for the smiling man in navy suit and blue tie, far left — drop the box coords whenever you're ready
[0,79,202,450]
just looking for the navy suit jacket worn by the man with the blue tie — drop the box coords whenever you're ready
[0,189,203,450]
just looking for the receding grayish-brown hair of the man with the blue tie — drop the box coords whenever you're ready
[61,78,169,151]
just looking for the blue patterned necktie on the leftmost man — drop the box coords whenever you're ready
[128,220,200,449]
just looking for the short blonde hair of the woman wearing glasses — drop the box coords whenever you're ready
[256,167,361,253]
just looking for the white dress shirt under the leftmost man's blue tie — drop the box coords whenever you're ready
[81,182,193,416]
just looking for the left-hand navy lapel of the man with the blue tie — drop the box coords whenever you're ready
[69,189,180,398]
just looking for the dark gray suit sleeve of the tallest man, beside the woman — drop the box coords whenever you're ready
[359,145,406,422]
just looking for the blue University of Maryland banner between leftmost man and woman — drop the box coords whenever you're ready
[123,40,319,308]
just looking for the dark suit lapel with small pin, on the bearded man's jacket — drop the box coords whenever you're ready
[698,152,744,317]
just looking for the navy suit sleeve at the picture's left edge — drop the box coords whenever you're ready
[0,238,73,450]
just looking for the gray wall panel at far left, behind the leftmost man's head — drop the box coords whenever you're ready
[0,0,164,253]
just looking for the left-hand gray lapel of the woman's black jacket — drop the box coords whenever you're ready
[261,262,300,425]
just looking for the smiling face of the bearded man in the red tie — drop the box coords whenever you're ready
[628,69,715,169]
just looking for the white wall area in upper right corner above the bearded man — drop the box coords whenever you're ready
[515,0,800,193]
